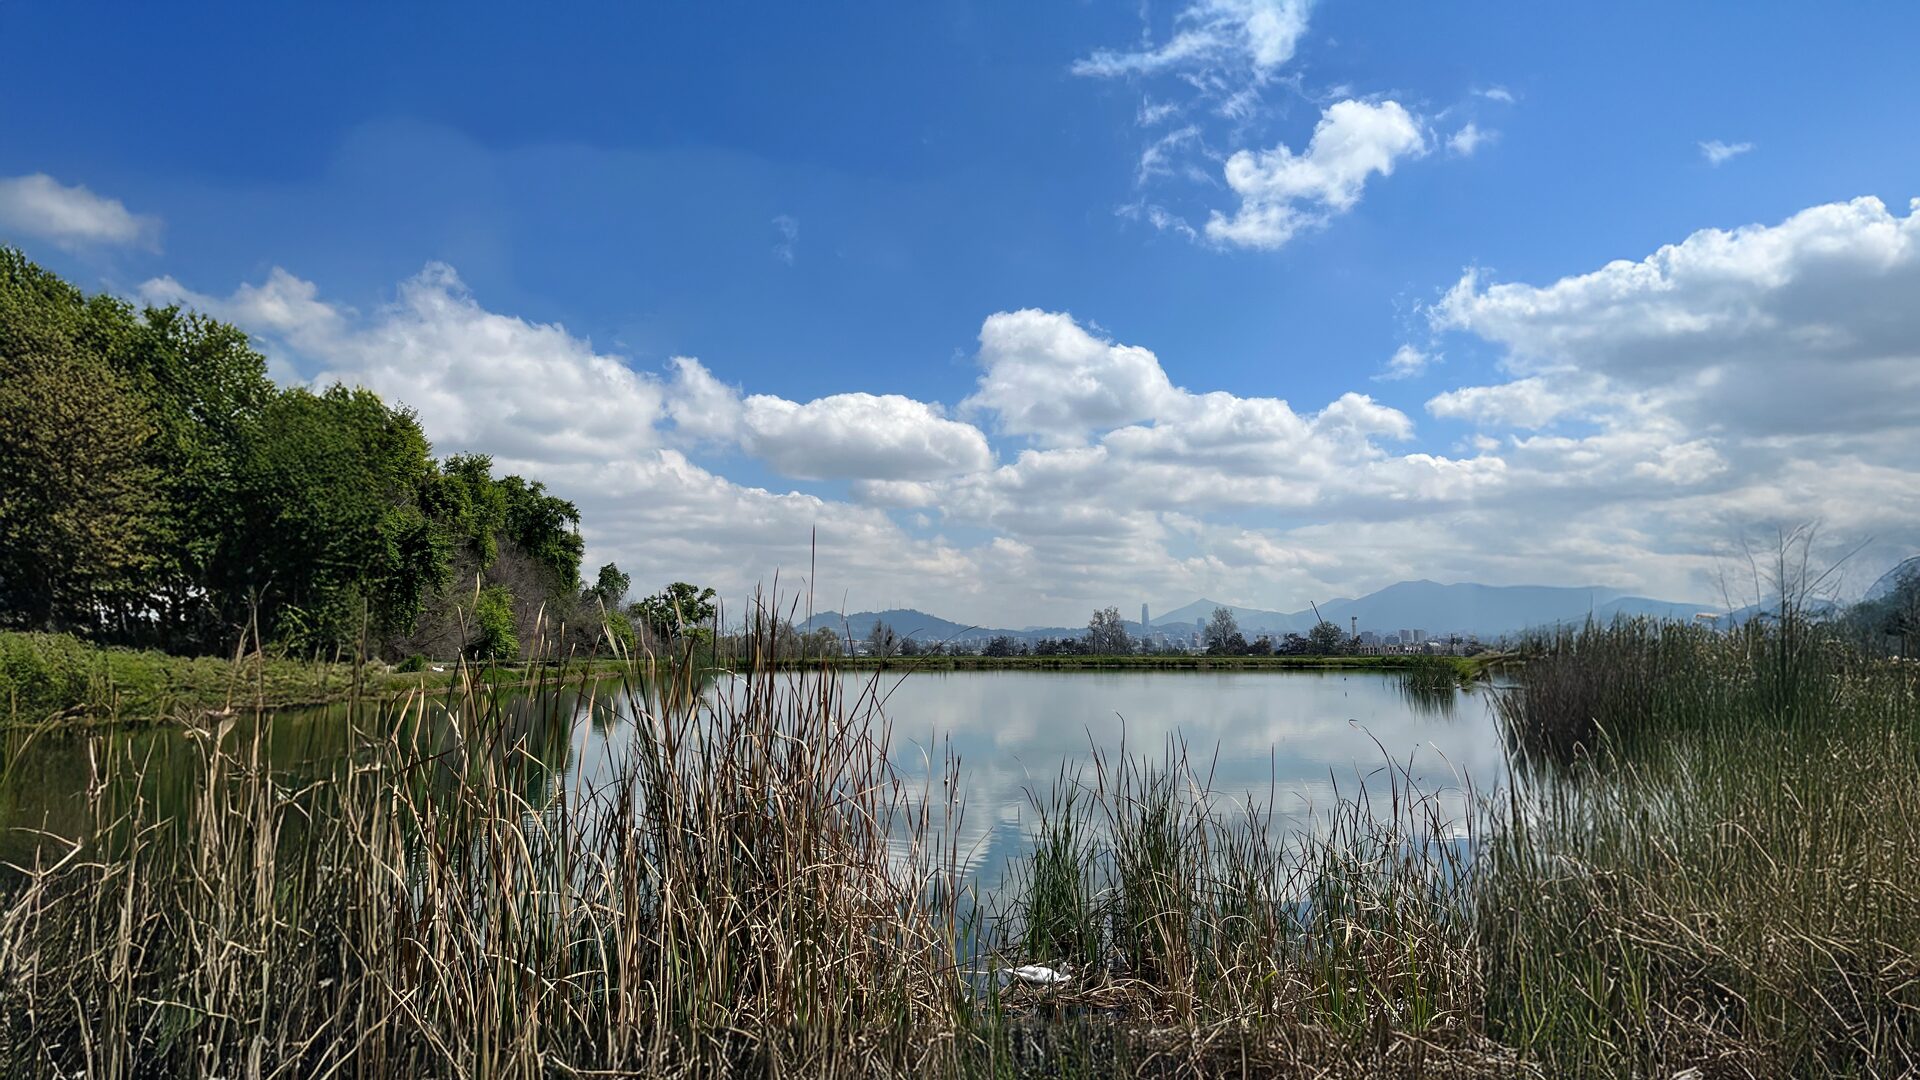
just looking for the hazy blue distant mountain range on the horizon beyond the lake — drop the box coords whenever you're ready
[804,580,1701,642]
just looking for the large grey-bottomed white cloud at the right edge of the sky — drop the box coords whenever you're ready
[1432,196,1920,434]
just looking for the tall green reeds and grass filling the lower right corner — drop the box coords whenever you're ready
[1475,621,1920,1076]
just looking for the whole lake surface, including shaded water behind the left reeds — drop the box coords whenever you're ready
[0,671,1505,888]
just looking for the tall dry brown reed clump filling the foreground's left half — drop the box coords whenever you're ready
[0,611,962,1076]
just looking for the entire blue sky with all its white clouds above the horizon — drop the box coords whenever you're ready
[0,0,1920,623]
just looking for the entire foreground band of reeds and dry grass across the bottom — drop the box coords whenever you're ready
[0,599,1920,1076]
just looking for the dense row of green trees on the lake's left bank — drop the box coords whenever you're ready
[0,250,599,655]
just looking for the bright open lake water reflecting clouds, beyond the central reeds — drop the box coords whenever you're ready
[570,671,1507,884]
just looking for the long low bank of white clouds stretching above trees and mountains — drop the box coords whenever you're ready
[135,186,1920,625]
